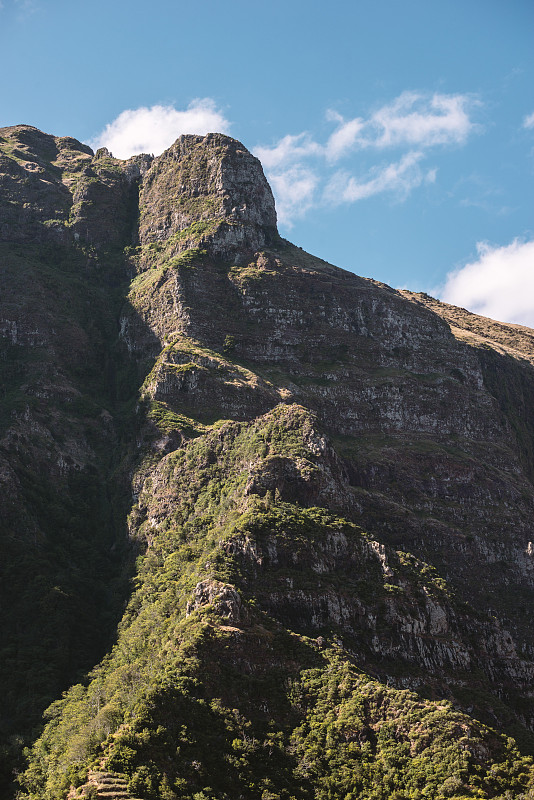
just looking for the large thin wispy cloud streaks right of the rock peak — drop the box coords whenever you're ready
[255,92,479,225]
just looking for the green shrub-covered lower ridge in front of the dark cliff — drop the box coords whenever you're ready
[15,406,532,800]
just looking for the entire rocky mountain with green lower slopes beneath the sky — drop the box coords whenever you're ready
[0,125,534,800]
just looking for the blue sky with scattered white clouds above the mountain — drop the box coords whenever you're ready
[0,0,534,326]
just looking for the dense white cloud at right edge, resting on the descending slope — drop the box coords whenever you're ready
[439,239,534,327]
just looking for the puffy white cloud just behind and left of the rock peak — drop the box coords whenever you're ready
[90,98,230,158]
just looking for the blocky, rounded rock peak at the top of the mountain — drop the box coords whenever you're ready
[140,133,278,261]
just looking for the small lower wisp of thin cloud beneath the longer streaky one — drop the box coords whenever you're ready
[324,152,436,205]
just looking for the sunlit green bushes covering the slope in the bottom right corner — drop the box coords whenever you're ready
[292,657,532,800]
